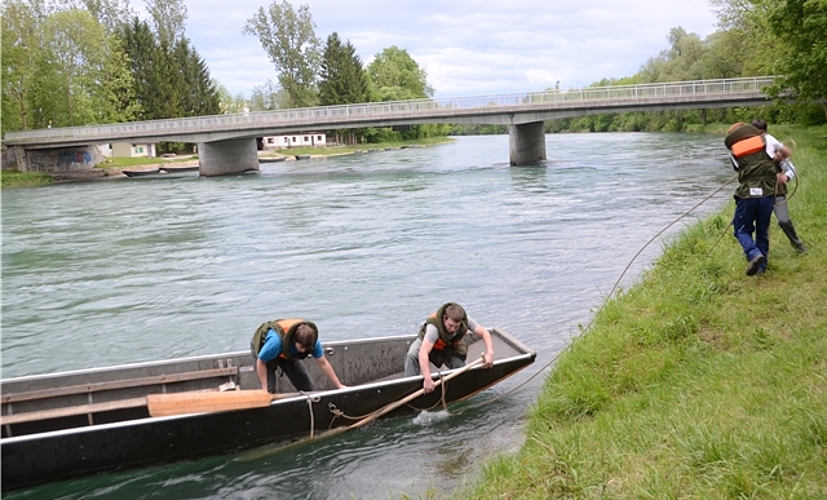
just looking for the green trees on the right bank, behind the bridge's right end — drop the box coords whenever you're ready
[451,0,827,134]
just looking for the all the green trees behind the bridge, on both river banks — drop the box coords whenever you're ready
[2,0,827,143]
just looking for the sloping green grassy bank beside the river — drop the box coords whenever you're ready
[462,126,827,499]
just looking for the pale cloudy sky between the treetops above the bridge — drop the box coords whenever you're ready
[152,0,716,97]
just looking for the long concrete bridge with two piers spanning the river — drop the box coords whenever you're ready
[3,76,778,176]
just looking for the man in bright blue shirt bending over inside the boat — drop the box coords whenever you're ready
[252,318,347,394]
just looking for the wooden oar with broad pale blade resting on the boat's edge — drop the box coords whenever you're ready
[146,391,299,417]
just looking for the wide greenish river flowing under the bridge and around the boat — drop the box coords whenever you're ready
[2,133,732,500]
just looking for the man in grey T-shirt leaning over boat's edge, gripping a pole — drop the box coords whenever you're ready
[405,302,494,393]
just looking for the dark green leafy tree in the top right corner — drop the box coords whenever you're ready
[770,0,827,103]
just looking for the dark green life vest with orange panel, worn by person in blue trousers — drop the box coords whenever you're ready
[724,124,778,198]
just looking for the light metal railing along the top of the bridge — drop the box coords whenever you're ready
[5,76,778,142]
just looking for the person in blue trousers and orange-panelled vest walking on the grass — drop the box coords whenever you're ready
[724,122,778,276]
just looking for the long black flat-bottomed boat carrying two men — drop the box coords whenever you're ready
[0,328,536,491]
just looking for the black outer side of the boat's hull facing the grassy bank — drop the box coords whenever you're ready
[0,328,535,490]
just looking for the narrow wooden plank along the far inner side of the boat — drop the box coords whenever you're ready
[0,366,238,404]
